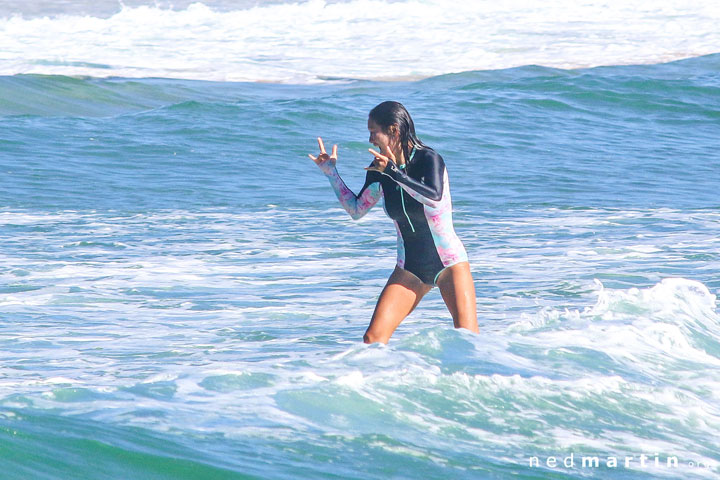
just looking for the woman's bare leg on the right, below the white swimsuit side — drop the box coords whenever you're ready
[437,262,479,333]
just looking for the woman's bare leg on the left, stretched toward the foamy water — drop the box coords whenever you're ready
[363,267,432,343]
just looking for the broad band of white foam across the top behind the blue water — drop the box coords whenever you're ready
[0,0,720,83]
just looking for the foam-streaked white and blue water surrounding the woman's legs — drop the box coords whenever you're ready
[0,209,720,476]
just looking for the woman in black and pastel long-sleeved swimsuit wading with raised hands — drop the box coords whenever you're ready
[309,102,478,343]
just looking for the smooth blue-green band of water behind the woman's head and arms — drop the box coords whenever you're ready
[0,55,720,211]
